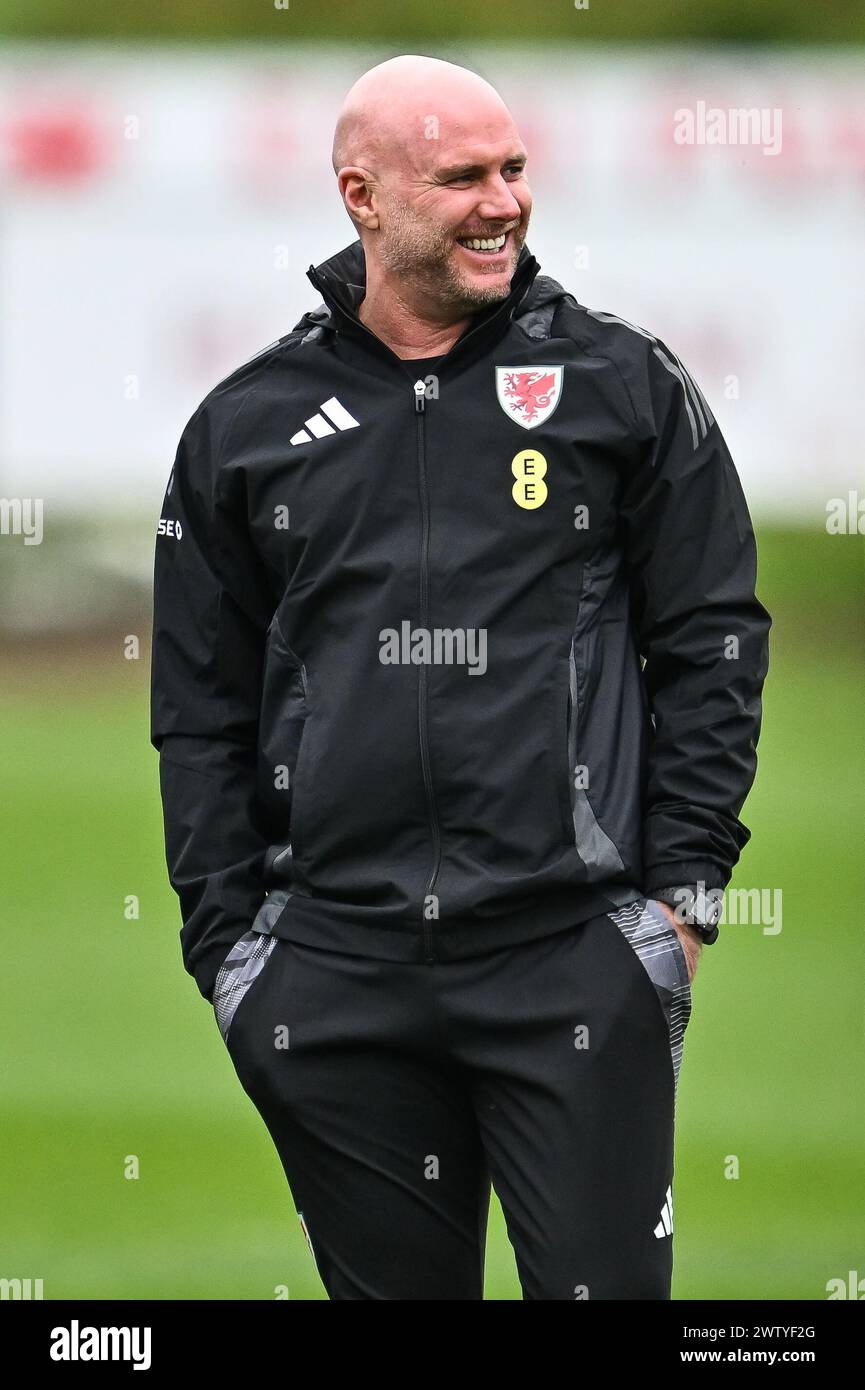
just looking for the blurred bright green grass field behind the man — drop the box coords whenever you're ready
[0,531,865,1300]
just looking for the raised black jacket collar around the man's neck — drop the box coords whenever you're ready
[306,239,541,367]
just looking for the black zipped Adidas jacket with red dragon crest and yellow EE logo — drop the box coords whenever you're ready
[152,242,770,998]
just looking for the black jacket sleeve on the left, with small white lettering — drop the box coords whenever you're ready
[150,402,275,999]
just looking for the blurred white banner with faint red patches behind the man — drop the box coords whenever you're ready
[0,44,865,527]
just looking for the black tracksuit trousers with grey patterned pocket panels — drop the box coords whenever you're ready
[214,897,691,1300]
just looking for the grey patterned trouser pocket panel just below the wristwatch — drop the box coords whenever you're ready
[606,898,691,1084]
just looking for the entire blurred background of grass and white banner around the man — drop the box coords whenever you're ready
[0,0,865,1300]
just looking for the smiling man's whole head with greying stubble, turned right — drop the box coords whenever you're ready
[334,57,531,318]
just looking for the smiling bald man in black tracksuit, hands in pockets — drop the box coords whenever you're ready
[152,56,770,1300]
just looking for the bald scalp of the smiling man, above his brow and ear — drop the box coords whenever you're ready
[332,53,509,177]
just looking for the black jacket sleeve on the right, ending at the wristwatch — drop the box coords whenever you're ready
[622,341,772,895]
